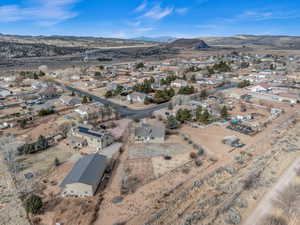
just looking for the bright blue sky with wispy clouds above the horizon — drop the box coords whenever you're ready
[0,0,300,38]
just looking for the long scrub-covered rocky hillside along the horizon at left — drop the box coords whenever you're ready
[0,34,154,59]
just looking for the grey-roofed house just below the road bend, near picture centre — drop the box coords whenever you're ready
[134,123,165,143]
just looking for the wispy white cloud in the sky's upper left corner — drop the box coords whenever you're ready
[0,0,79,26]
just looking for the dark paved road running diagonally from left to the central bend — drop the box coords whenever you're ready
[55,81,169,119]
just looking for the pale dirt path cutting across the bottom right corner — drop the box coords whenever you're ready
[243,157,300,225]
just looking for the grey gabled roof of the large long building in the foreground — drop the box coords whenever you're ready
[60,153,107,189]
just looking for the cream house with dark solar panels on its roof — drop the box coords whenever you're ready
[72,124,114,150]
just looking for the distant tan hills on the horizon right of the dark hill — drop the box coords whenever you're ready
[199,35,300,50]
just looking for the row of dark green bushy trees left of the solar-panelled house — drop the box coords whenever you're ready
[17,136,50,155]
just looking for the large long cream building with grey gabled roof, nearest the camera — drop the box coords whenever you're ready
[59,153,108,197]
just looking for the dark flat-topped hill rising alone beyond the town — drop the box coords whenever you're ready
[167,38,209,50]
